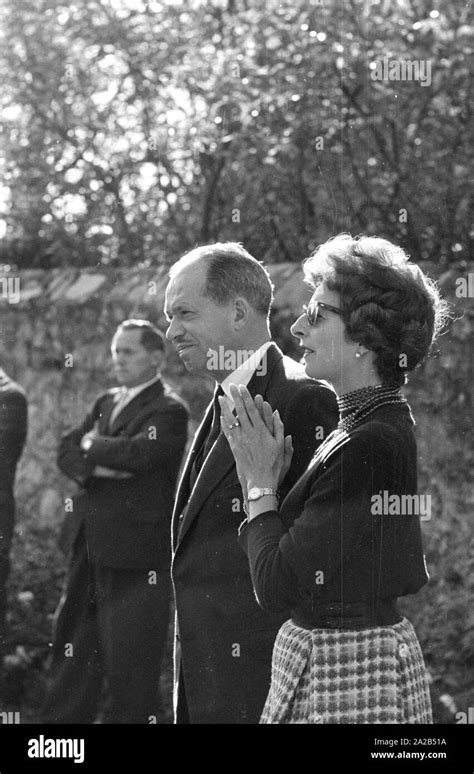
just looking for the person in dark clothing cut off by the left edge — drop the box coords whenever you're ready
[0,368,28,668]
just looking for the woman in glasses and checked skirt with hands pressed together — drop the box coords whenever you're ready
[221,234,447,724]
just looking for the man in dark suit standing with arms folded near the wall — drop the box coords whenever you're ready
[42,320,187,723]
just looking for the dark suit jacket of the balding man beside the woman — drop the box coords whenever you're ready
[172,345,338,723]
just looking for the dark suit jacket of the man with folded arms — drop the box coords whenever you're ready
[58,382,187,570]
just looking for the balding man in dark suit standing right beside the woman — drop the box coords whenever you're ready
[165,242,338,723]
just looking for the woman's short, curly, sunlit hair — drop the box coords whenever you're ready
[303,234,449,386]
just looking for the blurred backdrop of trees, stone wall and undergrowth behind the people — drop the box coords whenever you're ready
[0,0,474,723]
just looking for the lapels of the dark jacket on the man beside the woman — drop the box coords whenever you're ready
[173,344,283,550]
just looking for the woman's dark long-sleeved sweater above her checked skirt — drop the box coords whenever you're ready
[239,405,428,622]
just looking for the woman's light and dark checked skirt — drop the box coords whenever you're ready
[260,618,433,724]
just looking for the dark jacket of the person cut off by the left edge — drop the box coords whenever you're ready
[0,369,28,553]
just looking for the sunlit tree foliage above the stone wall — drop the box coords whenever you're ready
[0,0,472,267]
